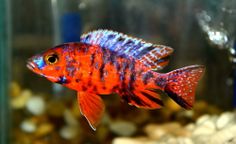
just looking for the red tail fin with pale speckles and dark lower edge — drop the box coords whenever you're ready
[164,65,205,109]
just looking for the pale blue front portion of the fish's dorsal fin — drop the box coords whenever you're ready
[80,30,155,59]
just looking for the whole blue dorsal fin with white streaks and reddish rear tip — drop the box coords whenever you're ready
[80,30,173,70]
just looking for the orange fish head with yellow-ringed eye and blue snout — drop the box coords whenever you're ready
[27,44,71,84]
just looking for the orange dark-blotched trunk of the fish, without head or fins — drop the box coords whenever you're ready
[60,43,161,94]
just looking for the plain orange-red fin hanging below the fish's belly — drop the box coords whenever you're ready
[77,92,105,130]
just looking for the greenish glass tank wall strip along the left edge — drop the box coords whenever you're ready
[0,0,11,143]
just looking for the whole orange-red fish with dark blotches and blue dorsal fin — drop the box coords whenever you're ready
[27,30,204,130]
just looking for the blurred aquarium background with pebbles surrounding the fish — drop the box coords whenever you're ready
[0,0,236,144]
